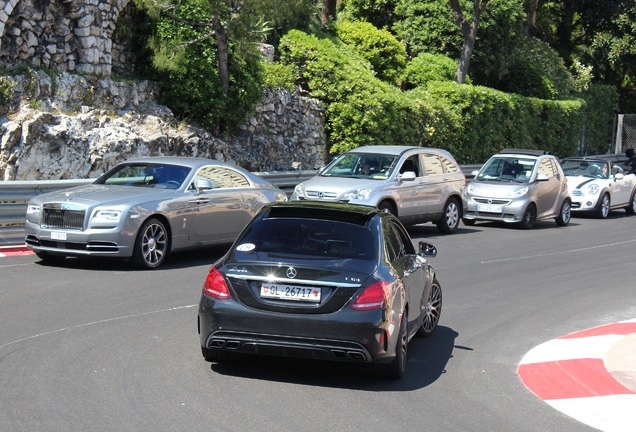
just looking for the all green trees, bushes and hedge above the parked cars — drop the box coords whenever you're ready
[123,0,636,163]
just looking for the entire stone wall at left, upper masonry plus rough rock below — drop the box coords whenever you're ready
[0,0,327,181]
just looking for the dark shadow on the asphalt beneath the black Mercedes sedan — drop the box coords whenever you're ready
[211,326,458,392]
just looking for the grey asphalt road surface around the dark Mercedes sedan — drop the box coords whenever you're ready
[0,211,636,432]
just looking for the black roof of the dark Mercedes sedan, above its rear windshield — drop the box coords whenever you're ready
[264,201,389,225]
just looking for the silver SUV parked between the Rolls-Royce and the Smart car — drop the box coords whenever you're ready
[290,145,466,233]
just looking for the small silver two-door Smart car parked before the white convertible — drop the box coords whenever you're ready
[463,149,572,229]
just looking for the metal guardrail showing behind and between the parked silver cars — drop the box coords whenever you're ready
[0,165,481,246]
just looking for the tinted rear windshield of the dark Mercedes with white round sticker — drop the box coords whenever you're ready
[234,218,376,260]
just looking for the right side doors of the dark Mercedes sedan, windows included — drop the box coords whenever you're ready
[386,220,428,333]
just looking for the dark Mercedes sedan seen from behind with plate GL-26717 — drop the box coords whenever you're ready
[198,201,442,379]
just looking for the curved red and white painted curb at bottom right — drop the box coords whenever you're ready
[518,320,636,432]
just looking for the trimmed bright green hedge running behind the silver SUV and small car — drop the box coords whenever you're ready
[280,31,586,163]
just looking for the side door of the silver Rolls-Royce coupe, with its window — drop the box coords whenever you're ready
[188,165,250,244]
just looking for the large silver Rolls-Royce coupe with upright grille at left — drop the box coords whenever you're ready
[25,157,287,269]
